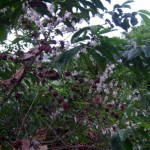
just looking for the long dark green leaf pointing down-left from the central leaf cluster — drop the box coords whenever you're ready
[56,45,83,66]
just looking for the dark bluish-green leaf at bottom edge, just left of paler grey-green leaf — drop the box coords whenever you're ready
[111,133,123,150]
